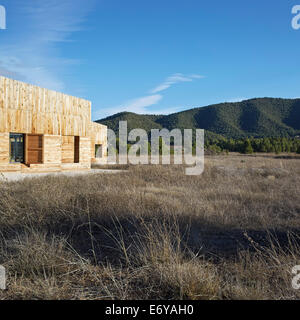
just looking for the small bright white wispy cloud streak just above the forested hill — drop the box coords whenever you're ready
[99,73,204,117]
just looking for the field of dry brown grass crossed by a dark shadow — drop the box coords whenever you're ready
[0,155,300,299]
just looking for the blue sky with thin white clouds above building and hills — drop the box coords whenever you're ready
[0,0,300,120]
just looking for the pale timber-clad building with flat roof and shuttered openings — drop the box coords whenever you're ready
[0,77,107,172]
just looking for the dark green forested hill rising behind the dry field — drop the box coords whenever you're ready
[97,98,300,138]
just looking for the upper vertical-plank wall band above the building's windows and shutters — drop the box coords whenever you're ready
[0,77,91,137]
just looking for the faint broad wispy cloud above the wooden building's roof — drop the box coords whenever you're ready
[0,0,95,90]
